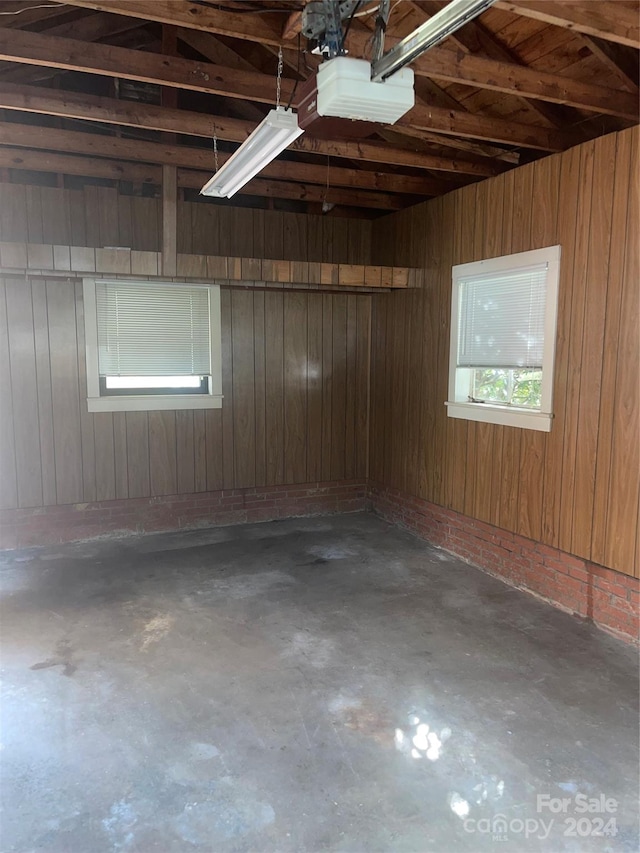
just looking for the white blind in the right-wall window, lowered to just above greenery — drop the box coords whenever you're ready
[458,264,547,368]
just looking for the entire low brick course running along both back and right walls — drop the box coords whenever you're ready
[0,480,640,642]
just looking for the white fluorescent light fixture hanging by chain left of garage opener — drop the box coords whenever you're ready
[200,108,304,198]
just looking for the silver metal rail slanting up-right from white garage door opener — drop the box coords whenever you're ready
[371,0,495,83]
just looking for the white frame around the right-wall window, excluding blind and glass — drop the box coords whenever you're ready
[445,245,561,432]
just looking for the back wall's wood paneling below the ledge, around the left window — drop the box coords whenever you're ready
[0,277,371,508]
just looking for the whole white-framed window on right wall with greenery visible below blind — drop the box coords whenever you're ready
[447,246,560,432]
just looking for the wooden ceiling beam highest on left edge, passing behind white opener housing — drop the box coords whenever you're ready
[0,27,596,151]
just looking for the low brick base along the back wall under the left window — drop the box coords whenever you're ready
[0,480,366,549]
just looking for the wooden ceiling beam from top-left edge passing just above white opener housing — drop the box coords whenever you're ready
[57,0,638,120]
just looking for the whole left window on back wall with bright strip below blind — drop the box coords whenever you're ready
[83,278,222,412]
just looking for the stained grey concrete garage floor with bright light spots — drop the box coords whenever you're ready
[0,514,638,853]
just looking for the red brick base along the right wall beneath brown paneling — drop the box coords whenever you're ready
[368,483,640,643]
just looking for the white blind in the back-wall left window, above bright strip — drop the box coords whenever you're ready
[96,281,211,376]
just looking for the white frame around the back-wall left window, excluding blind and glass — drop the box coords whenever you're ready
[82,276,223,412]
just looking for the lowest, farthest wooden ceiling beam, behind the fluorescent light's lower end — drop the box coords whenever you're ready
[0,147,405,210]
